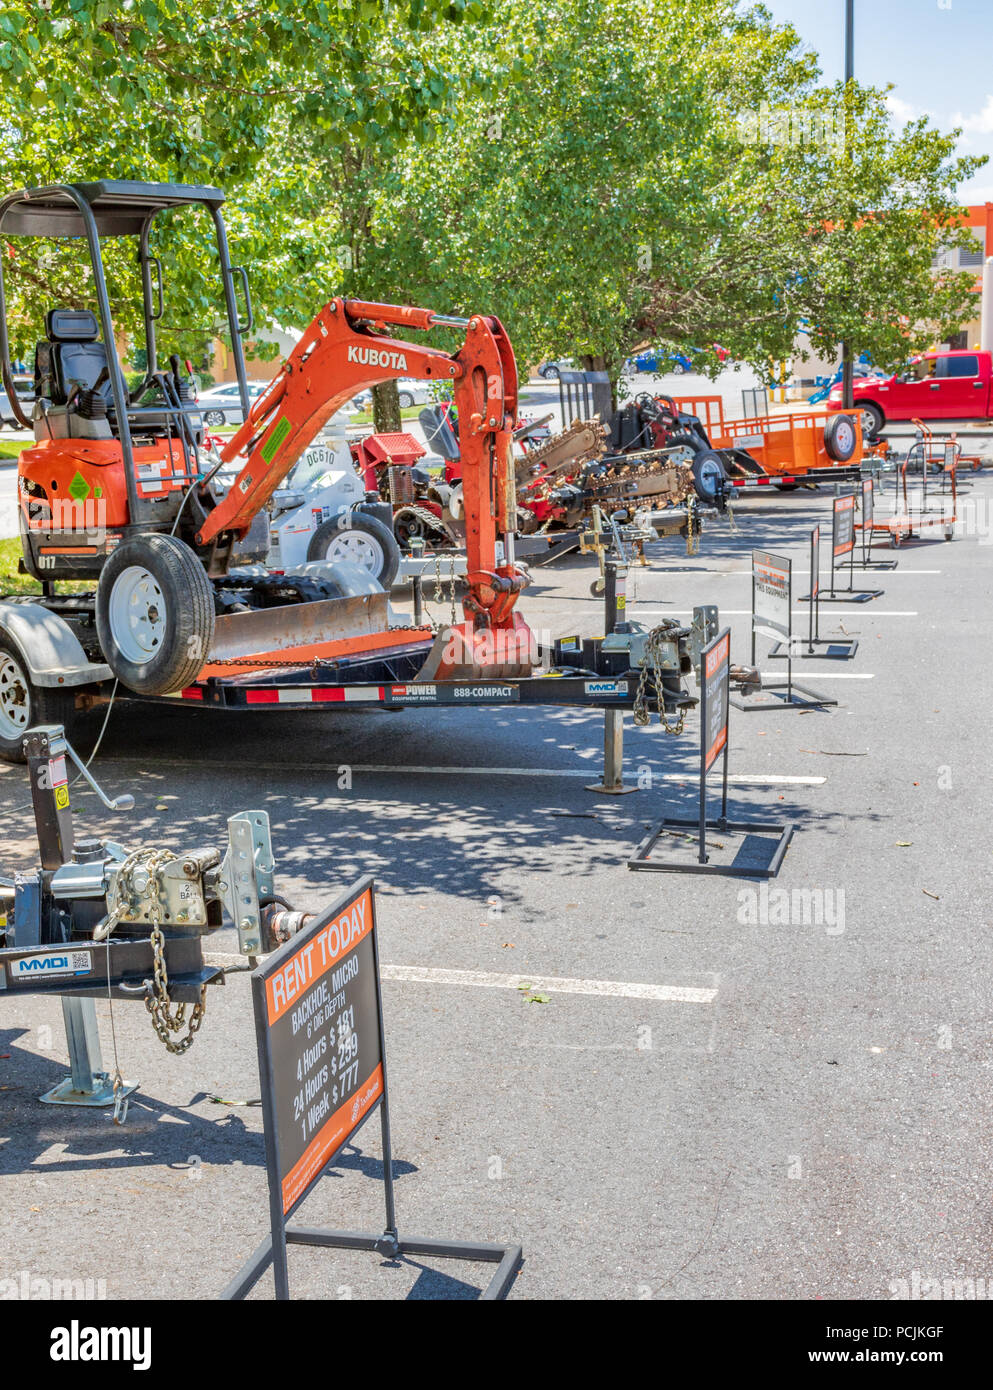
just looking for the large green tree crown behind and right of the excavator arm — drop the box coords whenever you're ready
[364,0,978,394]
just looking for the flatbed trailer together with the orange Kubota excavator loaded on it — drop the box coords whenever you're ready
[0,181,728,760]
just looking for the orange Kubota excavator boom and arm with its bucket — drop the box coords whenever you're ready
[196,299,533,680]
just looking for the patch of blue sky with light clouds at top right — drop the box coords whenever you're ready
[765,0,993,203]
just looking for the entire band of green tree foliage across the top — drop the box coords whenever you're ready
[0,0,978,391]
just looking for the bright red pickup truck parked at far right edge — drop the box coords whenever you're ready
[828,349,993,439]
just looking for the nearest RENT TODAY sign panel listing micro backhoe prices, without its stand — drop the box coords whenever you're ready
[252,878,384,1218]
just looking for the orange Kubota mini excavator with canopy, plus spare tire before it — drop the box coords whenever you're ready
[0,181,533,695]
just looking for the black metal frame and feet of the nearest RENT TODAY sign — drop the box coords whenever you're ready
[221,876,522,1301]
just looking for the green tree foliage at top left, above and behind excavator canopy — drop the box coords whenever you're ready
[0,0,483,375]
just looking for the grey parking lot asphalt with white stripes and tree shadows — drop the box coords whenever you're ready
[0,475,993,1300]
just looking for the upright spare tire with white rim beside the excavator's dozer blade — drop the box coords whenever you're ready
[96,534,214,695]
